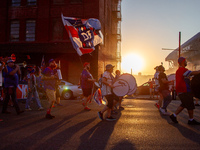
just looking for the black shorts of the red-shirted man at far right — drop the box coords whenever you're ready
[178,92,195,110]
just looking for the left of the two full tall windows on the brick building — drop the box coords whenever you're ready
[10,21,19,42]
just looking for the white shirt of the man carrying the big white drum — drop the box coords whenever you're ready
[101,71,114,96]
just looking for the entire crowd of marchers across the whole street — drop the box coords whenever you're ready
[0,57,200,125]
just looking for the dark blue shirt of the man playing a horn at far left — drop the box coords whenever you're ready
[3,66,19,88]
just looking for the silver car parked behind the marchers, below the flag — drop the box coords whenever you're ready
[59,80,83,100]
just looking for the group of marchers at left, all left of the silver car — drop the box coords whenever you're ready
[0,58,62,121]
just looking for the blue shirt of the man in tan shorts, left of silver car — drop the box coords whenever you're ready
[42,67,57,90]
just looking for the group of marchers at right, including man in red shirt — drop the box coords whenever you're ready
[154,57,200,125]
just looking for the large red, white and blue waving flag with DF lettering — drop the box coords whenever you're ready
[61,14,103,56]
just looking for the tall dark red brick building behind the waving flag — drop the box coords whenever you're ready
[0,0,121,84]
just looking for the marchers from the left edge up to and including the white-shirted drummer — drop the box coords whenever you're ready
[0,58,123,121]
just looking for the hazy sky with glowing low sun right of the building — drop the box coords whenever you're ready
[121,0,200,75]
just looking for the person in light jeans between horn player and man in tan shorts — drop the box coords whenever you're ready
[25,66,44,110]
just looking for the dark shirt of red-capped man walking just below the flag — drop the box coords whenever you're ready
[81,69,93,89]
